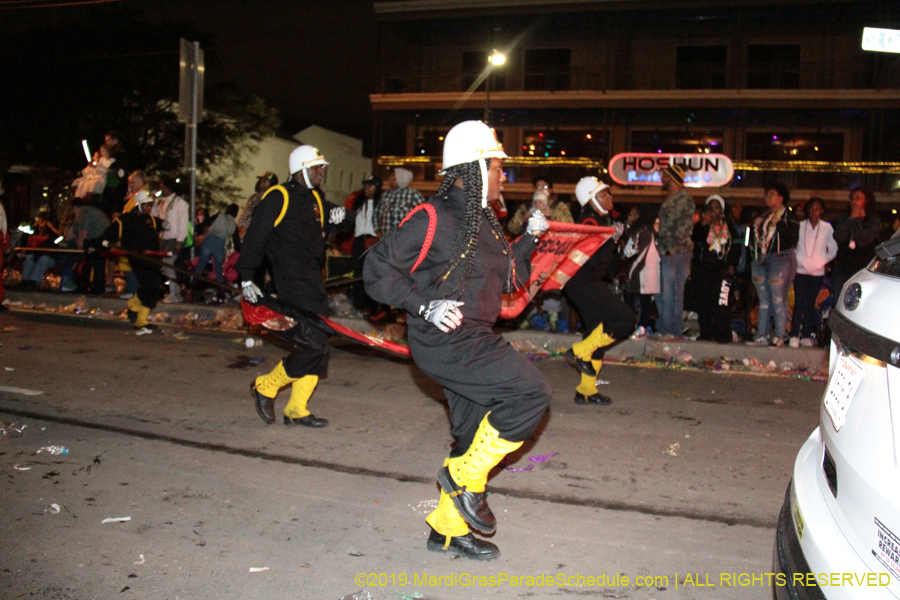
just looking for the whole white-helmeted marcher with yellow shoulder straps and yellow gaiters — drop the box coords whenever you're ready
[237,145,352,427]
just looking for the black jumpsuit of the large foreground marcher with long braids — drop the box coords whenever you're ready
[363,187,552,457]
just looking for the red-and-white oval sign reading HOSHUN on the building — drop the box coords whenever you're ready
[609,152,734,187]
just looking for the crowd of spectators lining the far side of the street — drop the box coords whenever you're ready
[0,131,900,347]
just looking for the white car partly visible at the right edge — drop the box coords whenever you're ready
[773,232,900,600]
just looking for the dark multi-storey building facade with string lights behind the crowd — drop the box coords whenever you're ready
[370,0,900,208]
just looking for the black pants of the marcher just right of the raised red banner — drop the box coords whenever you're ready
[563,277,635,360]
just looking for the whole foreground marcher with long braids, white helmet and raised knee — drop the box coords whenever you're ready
[363,121,551,560]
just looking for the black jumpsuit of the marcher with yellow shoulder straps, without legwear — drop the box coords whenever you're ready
[236,180,352,378]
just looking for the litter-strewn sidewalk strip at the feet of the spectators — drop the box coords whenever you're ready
[5,289,828,375]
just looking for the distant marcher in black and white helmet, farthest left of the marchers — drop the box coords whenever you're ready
[86,190,162,333]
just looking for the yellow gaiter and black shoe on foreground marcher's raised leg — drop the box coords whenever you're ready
[438,413,522,533]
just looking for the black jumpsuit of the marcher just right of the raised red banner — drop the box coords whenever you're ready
[563,205,635,360]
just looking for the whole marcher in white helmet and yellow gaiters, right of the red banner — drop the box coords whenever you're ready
[563,177,635,405]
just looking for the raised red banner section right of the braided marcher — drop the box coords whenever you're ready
[500,221,616,319]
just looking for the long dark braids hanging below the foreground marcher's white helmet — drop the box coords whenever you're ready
[436,159,516,294]
